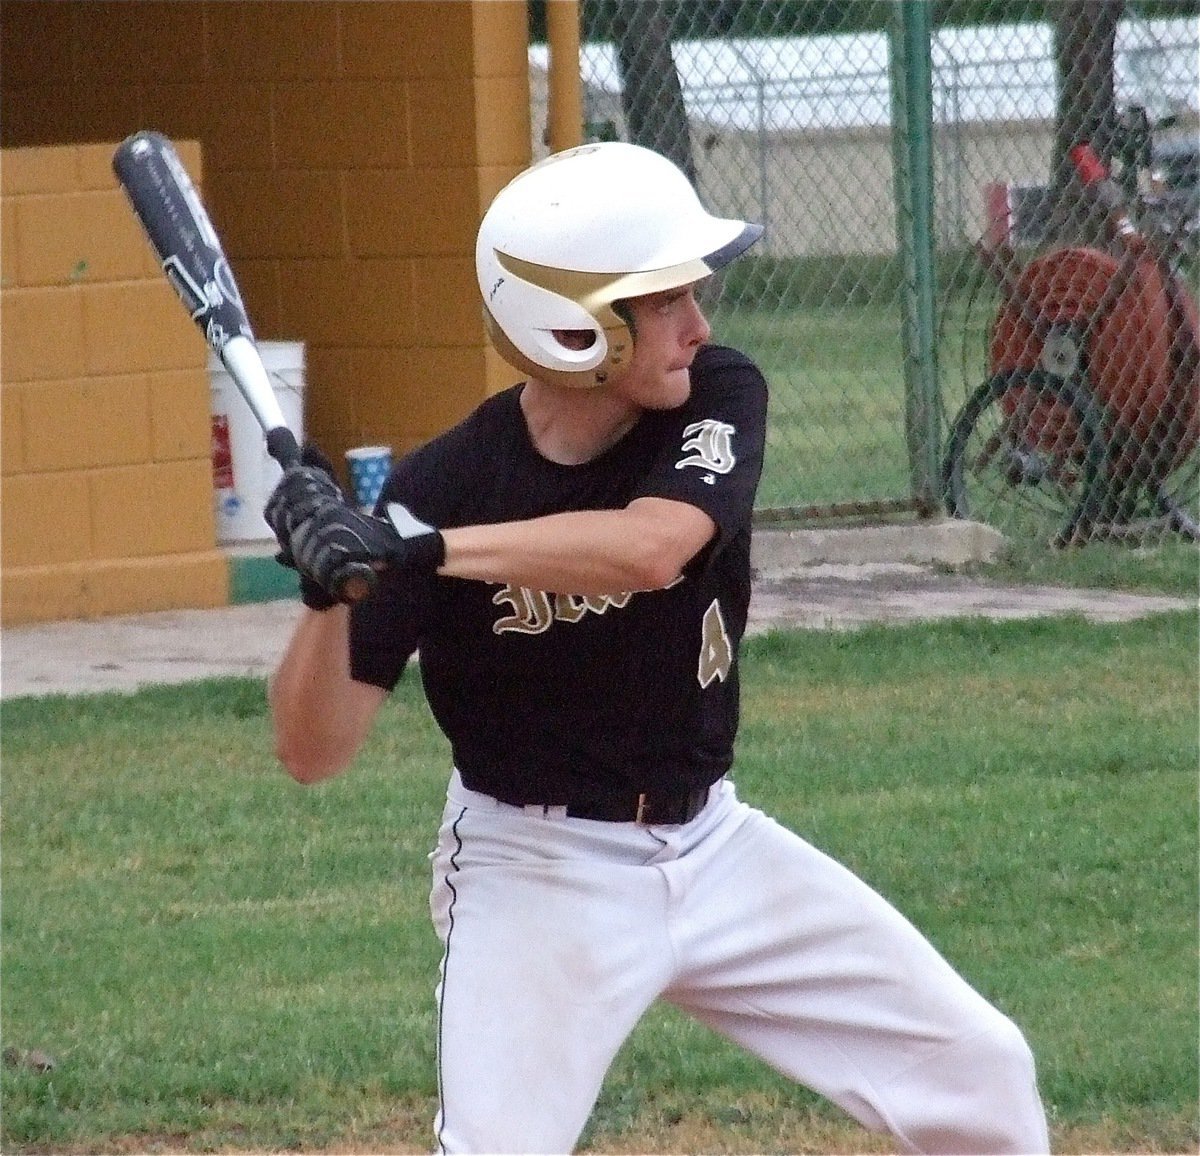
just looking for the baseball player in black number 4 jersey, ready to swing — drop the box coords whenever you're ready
[268,143,1048,1152]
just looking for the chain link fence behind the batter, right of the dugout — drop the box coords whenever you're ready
[530,0,1200,552]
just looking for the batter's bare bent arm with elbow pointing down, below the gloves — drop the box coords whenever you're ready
[268,606,383,783]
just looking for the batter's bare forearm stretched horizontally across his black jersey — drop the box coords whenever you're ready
[439,503,712,594]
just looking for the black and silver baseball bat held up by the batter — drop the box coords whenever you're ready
[113,131,377,603]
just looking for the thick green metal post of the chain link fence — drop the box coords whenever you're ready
[888,0,942,514]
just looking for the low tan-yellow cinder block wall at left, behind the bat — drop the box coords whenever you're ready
[0,142,228,623]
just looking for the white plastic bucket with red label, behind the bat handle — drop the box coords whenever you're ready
[209,341,305,545]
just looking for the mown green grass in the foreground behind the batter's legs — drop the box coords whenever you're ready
[0,613,1200,1152]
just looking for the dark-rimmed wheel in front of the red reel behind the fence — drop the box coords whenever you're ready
[942,370,1106,545]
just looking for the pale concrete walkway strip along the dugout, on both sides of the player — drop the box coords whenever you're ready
[7,523,1196,699]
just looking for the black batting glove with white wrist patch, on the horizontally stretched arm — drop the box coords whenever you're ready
[289,499,445,609]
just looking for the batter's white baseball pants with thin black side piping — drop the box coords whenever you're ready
[431,775,1049,1154]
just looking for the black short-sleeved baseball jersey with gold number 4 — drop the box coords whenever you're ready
[350,346,767,803]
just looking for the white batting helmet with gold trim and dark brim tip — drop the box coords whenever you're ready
[475,140,762,389]
